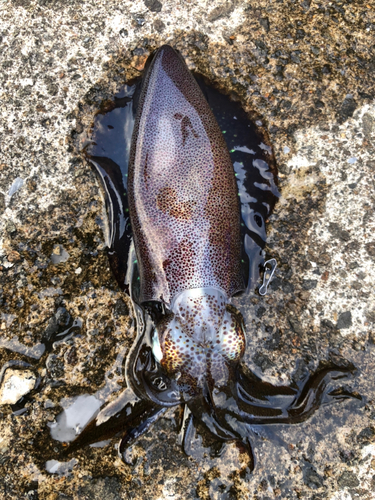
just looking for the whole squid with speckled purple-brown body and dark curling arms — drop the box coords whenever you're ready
[67,46,354,456]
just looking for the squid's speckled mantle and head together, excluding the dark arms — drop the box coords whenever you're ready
[128,46,245,390]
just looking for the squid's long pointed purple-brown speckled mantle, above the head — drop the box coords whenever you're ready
[128,46,244,305]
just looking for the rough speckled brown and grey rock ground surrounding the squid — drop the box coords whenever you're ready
[0,0,375,500]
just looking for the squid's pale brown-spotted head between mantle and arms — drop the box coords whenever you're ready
[157,289,245,392]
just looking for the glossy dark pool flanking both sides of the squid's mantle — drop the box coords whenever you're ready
[86,75,279,299]
